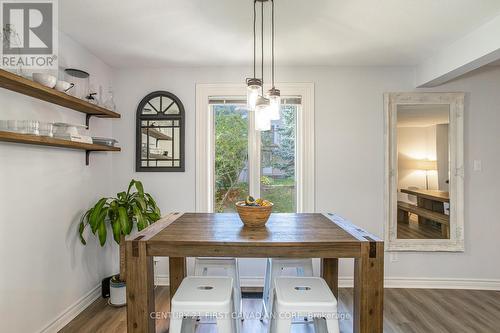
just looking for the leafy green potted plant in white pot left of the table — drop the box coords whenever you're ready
[78,179,160,305]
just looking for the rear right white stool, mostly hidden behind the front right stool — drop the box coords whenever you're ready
[261,258,313,318]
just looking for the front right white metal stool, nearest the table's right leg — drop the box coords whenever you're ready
[271,277,339,333]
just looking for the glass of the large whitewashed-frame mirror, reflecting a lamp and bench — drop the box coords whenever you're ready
[397,104,450,239]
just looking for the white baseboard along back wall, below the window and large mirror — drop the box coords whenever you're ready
[156,275,500,290]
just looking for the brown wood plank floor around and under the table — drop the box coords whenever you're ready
[60,287,500,333]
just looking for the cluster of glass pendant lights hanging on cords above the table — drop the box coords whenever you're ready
[246,0,281,131]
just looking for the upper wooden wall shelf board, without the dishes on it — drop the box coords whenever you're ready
[0,69,120,120]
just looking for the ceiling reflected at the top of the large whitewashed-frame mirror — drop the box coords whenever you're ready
[397,104,450,127]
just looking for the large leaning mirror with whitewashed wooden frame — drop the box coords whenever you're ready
[384,93,464,251]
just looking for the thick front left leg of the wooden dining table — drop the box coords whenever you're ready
[125,240,155,333]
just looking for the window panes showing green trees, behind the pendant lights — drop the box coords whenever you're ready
[209,97,300,213]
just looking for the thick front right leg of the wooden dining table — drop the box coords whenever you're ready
[354,241,384,333]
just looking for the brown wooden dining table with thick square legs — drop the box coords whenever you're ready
[125,213,384,333]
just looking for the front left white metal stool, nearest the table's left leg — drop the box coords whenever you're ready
[169,276,239,333]
